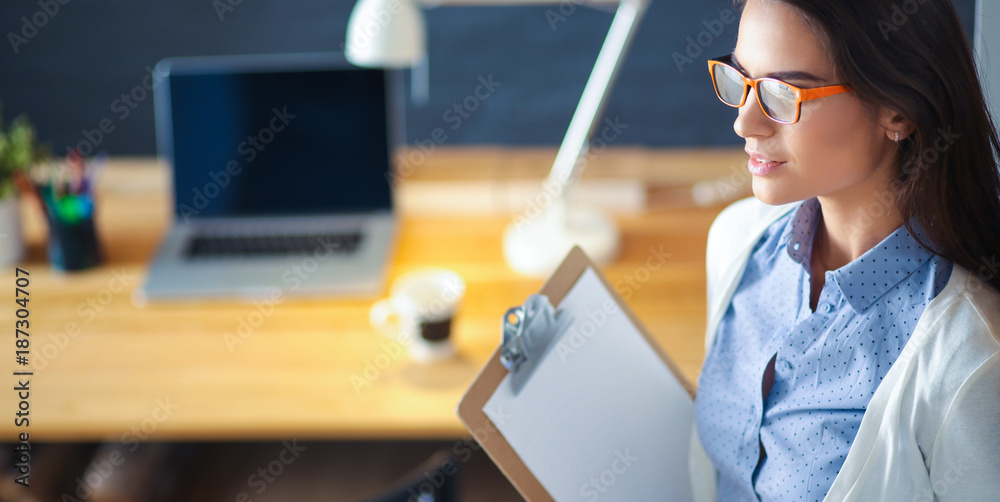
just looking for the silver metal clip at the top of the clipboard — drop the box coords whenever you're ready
[500,295,573,395]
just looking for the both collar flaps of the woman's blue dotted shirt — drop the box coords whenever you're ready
[782,198,934,313]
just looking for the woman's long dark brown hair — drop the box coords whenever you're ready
[736,0,1000,291]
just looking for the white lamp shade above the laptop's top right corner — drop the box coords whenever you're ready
[344,0,426,68]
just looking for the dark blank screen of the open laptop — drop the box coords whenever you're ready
[161,57,392,221]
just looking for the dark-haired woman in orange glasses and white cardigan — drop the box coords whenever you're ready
[692,0,1000,501]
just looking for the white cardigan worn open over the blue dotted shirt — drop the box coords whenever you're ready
[689,197,1000,502]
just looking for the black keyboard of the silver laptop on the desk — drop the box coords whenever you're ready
[185,232,363,258]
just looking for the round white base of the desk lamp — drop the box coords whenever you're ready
[503,206,621,278]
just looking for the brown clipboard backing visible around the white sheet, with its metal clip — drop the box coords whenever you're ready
[457,247,695,502]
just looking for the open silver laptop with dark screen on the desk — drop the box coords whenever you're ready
[136,54,396,303]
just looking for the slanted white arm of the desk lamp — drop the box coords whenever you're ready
[544,0,649,204]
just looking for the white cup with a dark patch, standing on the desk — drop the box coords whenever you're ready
[368,269,465,362]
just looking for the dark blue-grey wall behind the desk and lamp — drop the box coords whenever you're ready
[0,0,974,154]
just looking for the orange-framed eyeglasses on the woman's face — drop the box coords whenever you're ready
[708,56,851,124]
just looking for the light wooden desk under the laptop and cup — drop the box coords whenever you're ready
[0,149,745,441]
